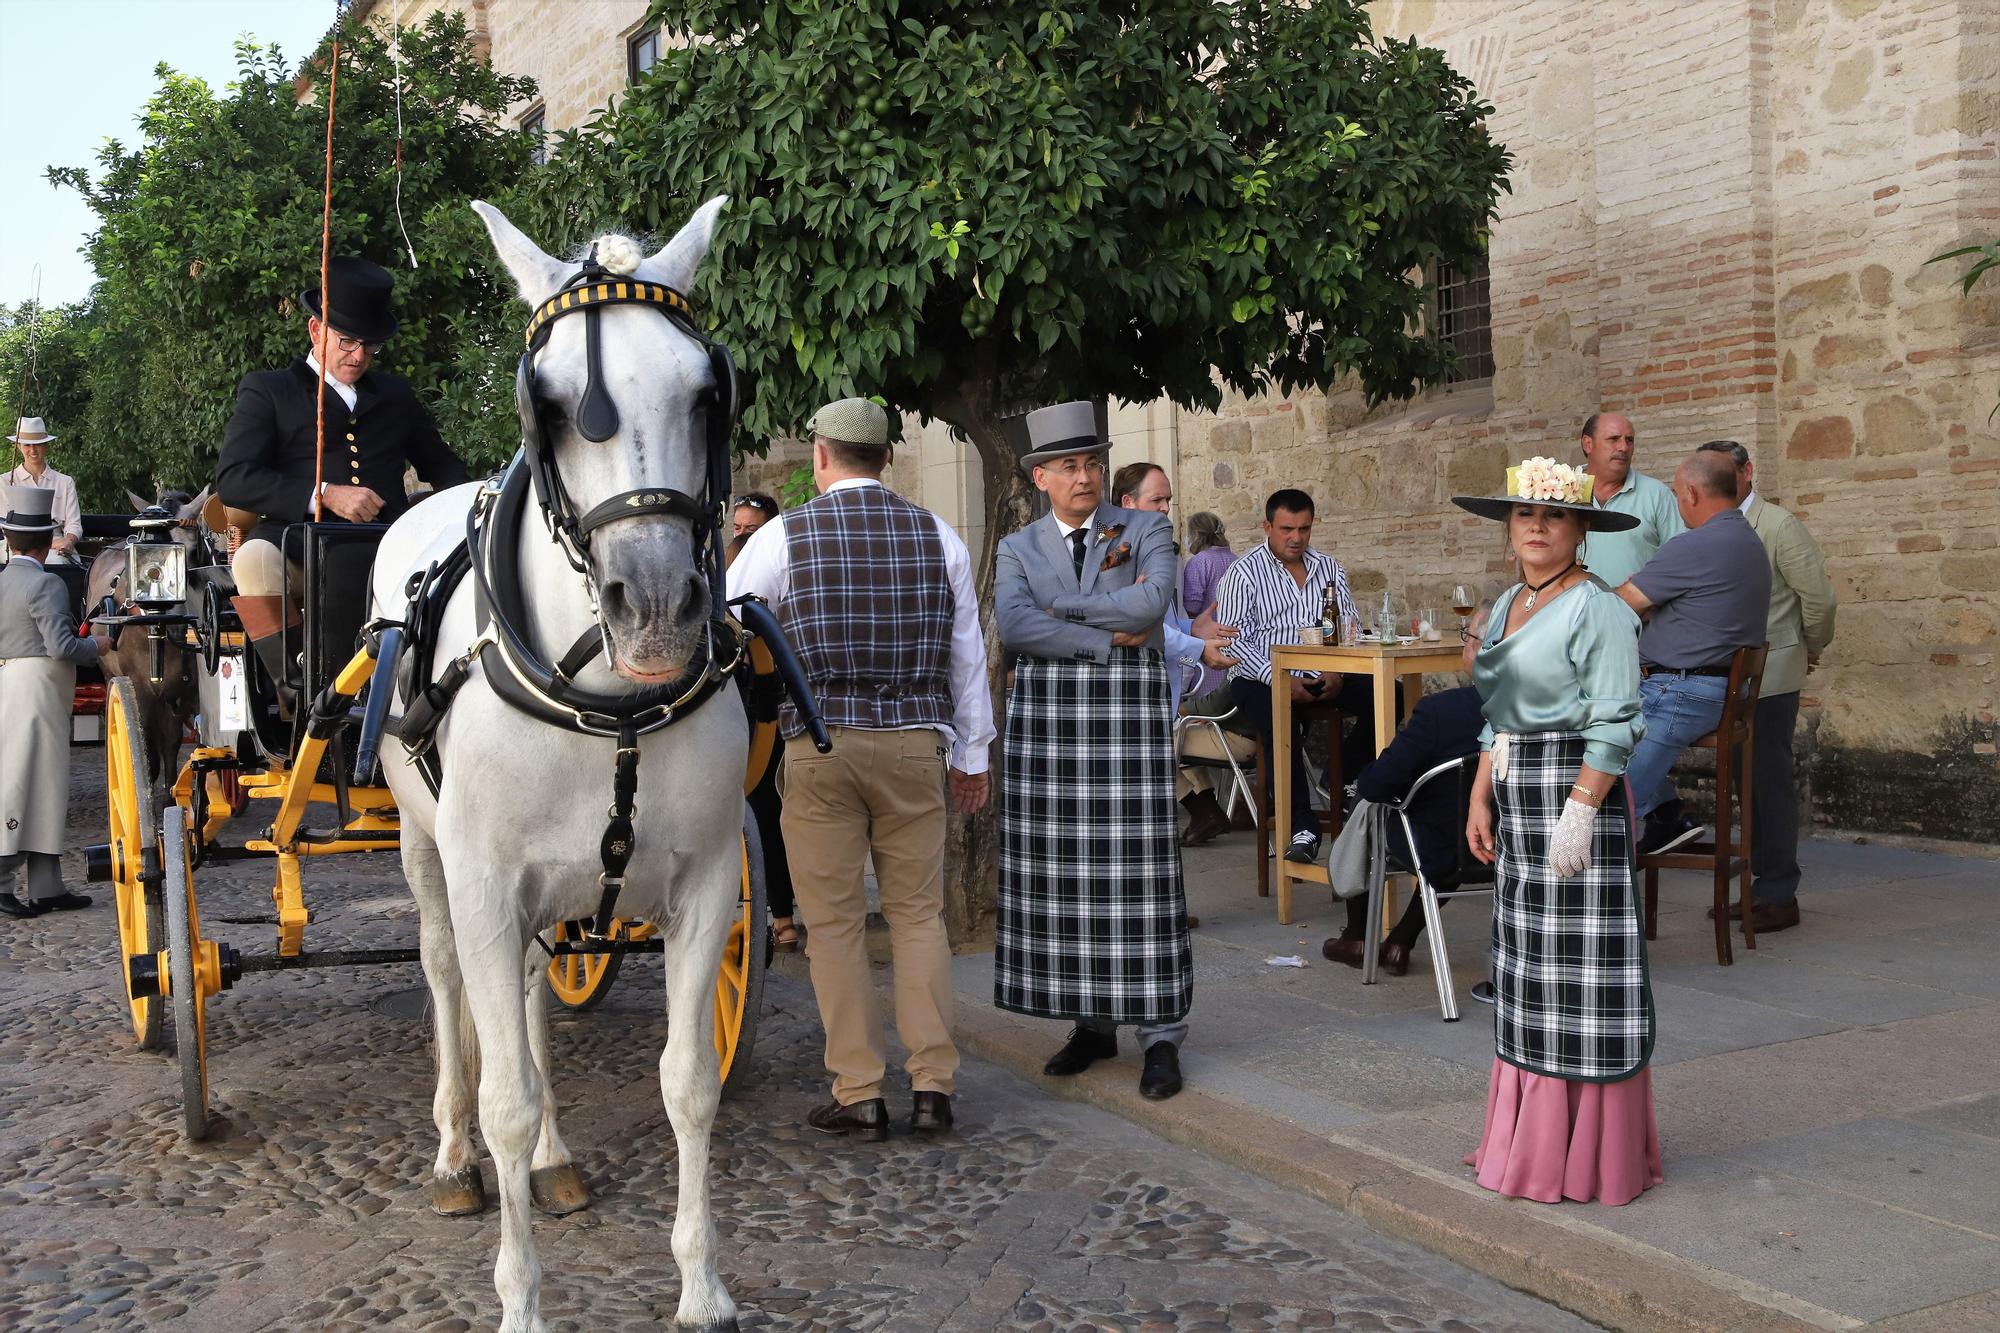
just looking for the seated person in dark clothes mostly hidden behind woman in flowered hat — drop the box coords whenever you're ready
[1320,598,1494,964]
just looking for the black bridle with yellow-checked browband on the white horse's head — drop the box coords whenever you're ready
[514,246,742,606]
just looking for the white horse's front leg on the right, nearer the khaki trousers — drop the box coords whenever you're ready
[660,880,738,1329]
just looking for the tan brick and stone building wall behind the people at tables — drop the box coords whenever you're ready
[1178,0,2000,841]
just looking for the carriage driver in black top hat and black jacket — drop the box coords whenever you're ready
[216,256,468,683]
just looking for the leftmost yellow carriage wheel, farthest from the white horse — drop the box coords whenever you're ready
[104,677,166,1051]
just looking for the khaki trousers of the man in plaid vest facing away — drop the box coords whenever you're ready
[778,727,958,1107]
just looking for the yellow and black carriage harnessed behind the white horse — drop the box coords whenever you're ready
[86,524,810,1139]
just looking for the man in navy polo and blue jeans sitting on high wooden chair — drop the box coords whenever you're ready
[1618,452,1770,840]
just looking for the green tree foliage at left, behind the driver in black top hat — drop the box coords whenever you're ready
[50,14,534,494]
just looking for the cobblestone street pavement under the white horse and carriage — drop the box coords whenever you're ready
[0,751,1586,1333]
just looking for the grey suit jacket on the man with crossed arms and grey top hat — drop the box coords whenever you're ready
[994,504,1174,662]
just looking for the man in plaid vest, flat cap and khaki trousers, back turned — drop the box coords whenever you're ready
[728,398,994,1143]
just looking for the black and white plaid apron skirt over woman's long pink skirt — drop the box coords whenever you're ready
[1494,731,1654,1083]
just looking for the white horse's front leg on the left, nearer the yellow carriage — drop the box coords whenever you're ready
[446,872,542,1333]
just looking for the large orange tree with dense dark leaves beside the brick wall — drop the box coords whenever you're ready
[520,0,1508,931]
